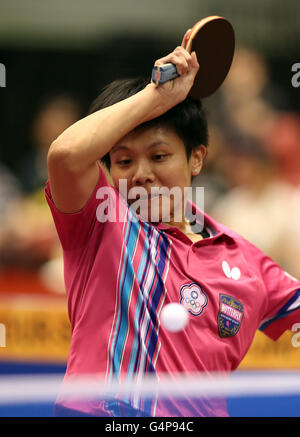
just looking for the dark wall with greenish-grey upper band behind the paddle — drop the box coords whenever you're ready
[0,0,300,177]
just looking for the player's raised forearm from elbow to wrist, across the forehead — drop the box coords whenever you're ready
[48,86,164,171]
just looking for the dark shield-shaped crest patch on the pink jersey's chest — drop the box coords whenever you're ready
[218,294,244,338]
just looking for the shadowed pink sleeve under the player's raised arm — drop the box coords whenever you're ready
[44,163,112,251]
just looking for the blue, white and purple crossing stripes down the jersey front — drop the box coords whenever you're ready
[109,210,171,413]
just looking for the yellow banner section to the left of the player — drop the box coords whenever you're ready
[0,297,71,362]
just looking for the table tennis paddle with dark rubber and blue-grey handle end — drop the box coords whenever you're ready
[152,16,235,99]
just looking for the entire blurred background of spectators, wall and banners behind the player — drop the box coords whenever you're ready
[0,0,300,414]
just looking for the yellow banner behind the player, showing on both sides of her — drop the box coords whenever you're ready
[0,296,300,370]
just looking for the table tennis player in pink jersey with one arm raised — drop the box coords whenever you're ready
[45,47,300,416]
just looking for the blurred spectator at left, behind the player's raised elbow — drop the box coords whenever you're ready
[0,96,80,292]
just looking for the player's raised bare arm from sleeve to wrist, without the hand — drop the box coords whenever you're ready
[47,86,163,213]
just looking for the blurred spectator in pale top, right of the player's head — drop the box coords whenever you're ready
[211,138,300,277]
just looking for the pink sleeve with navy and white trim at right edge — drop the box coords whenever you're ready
[256,245,300,340]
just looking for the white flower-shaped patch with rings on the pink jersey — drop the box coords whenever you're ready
[180,282,208,316]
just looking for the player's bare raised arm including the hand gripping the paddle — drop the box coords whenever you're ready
[47,47,199,213]
